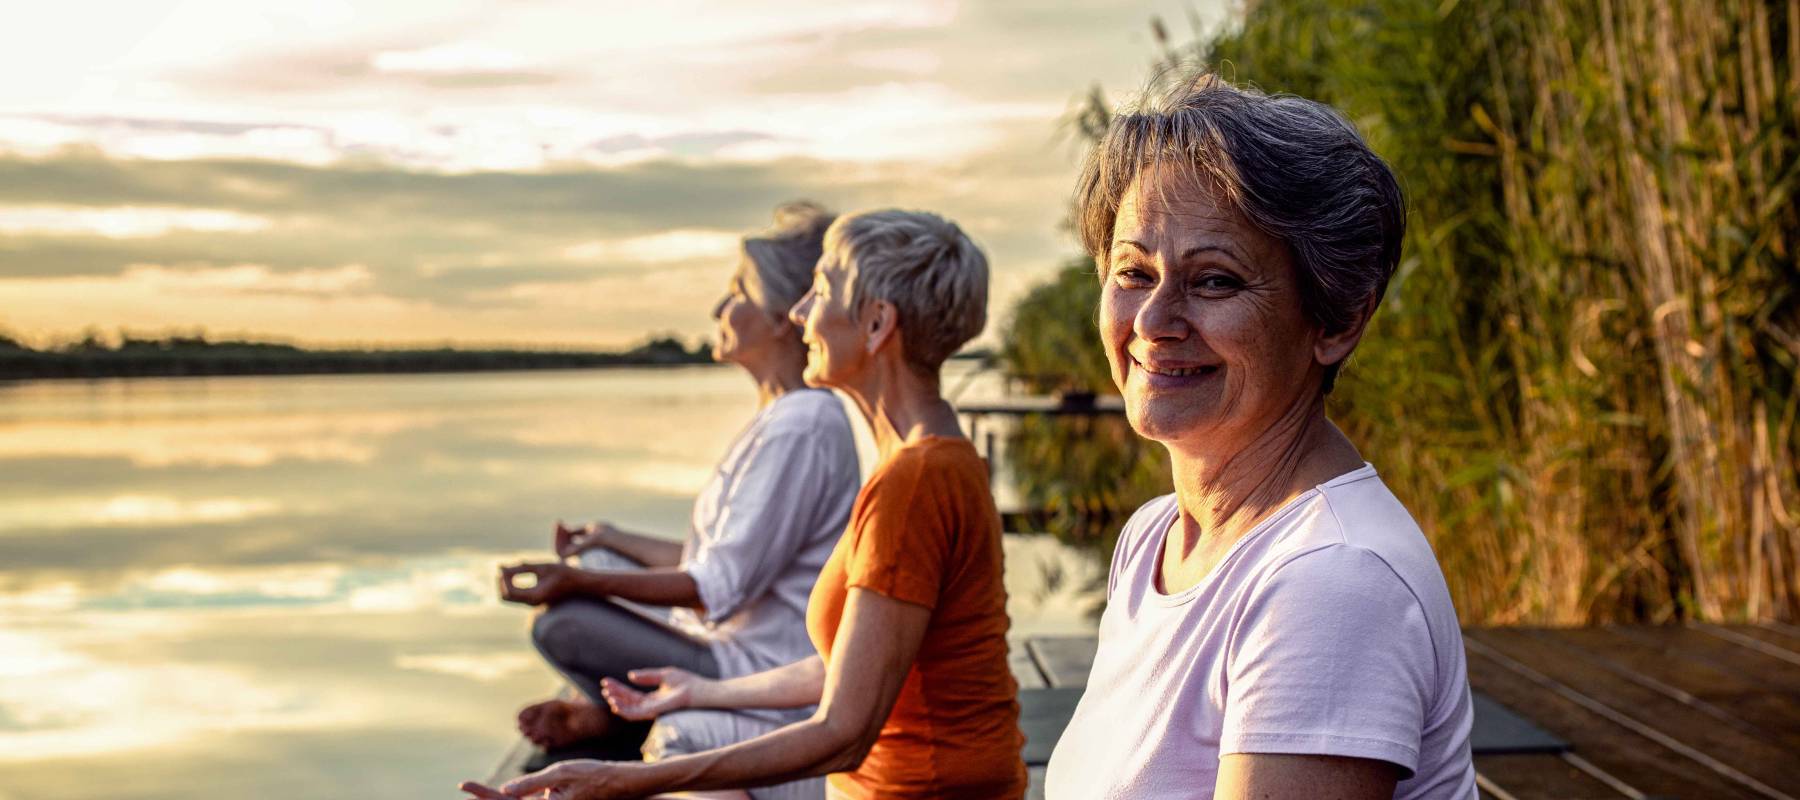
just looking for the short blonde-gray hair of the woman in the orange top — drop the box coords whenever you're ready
[824,209,988,373]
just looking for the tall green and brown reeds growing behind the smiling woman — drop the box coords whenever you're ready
[1004,0,1800,623]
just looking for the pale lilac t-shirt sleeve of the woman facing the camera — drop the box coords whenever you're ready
[1219,544,1436,777]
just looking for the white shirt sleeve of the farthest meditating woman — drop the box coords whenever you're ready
[682,431,837,623]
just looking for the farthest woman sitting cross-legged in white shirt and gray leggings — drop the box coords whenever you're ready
[500,204,860,800]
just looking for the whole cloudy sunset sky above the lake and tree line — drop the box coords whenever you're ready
[0,0,1222,346]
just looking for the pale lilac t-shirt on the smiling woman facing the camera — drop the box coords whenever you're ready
[1046,465,1476,800]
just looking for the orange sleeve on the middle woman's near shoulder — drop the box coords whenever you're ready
[844,463,952,609]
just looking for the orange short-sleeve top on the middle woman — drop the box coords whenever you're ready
[806,436,1026,800]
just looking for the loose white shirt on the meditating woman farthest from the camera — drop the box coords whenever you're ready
[671,389,862,677]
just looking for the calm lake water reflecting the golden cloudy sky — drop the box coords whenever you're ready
[0,364,1100,800]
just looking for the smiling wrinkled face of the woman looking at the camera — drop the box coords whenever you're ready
[1100,169,1323,452]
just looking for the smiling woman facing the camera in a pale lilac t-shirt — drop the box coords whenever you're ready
[1046,74,1474,800]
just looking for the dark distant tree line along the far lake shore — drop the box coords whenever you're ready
[0,333,713,380]
